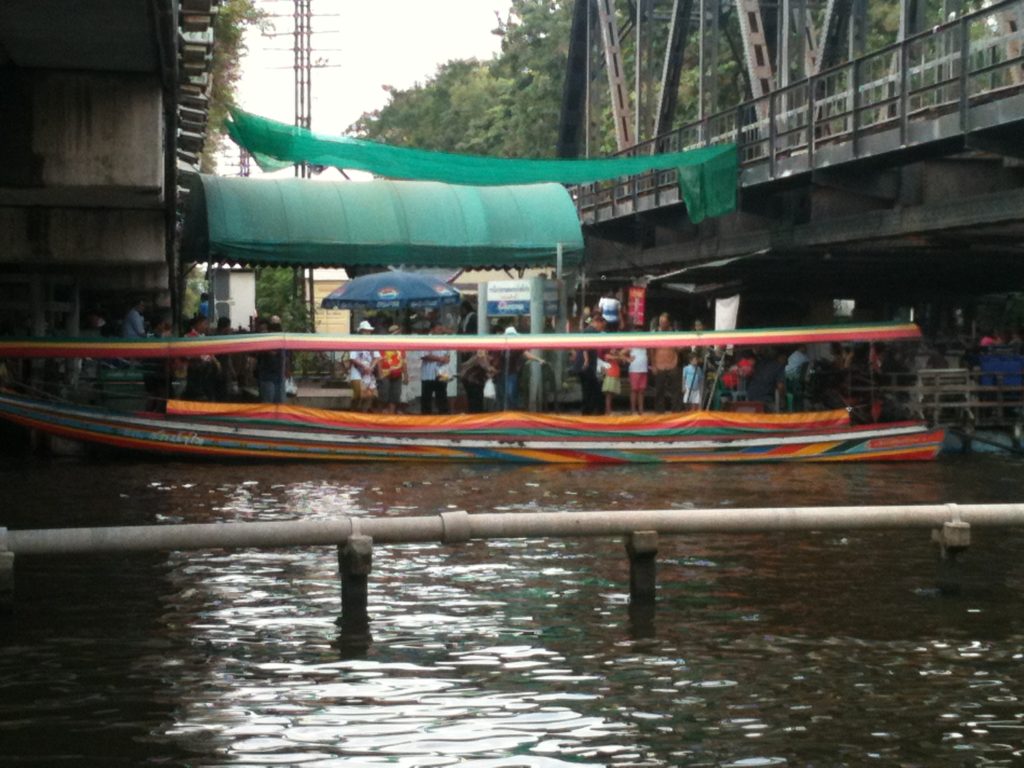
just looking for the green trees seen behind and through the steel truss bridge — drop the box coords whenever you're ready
[337,0,950,158]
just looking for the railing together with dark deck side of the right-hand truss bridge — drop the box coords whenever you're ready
[573,0,1024,301]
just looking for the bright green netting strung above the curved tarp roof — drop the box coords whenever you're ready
[227,110,737,223]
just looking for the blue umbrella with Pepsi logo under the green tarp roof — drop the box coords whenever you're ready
[321,271,461,309]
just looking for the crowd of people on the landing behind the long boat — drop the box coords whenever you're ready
[79,295,1019,415]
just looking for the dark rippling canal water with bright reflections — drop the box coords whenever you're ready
[0,456,1024,768]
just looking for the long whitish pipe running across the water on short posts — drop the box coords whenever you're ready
[6,504,1024,555]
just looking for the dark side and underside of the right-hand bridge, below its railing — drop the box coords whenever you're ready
[586,153,1024,299]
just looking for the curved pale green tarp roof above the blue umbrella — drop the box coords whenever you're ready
[181,175,583,267]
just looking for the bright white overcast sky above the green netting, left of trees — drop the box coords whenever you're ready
[223,0,509,173]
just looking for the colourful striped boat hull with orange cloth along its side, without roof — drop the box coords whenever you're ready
[0,394,943,464]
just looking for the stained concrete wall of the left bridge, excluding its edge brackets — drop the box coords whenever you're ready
[0,0,176,306]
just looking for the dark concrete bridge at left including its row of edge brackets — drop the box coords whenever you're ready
[0,0,216,335]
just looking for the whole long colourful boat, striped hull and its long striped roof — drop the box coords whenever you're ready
[0,324,943,464]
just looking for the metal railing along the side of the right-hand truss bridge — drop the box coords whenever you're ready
[572,0,1024,222]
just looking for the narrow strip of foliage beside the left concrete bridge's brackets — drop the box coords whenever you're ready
[200,0,267,173]
